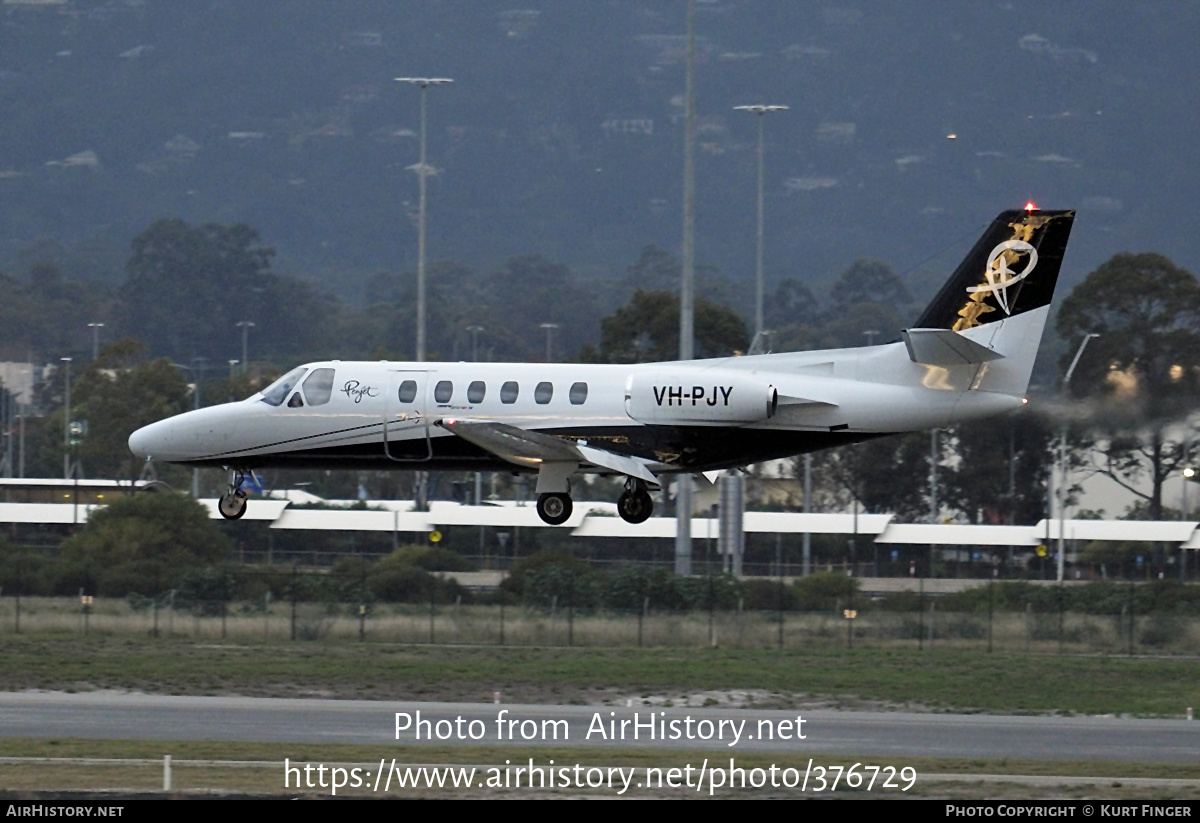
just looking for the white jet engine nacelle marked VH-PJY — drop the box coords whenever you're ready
[625,371,779,425]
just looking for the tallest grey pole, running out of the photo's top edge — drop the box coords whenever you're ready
[674,0,696,575]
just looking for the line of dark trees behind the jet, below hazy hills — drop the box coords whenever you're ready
[0,220,1200,542]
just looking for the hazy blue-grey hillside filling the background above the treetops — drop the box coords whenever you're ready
[0,0,1200,319]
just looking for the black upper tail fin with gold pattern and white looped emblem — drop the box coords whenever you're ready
[913,210,1075,331]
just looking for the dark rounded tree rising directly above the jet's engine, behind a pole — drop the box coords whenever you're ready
[582,289,750,364]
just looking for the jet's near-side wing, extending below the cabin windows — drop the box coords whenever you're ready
[434,419,659,486]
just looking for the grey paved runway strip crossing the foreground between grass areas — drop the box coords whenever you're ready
[0,692,1200,763]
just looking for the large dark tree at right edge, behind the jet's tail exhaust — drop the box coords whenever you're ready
[1058,253,1200,519]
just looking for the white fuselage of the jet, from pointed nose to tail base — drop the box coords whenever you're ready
[130,307,1049,471]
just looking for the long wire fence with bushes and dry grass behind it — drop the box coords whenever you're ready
[0,558,1200,654]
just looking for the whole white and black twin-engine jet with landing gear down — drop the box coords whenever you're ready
[130,206,1075,525]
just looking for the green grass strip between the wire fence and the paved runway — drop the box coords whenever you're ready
[0,635,1200,717]
